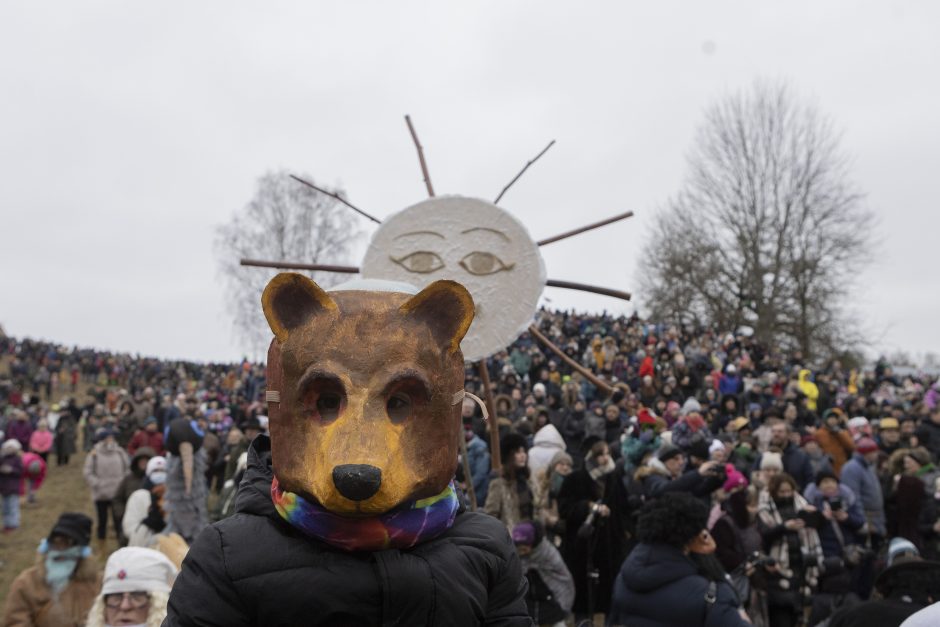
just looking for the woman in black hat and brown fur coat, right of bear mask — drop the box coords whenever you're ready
[483,433,535,531]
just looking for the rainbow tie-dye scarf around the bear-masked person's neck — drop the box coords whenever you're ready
[271,477,459,551]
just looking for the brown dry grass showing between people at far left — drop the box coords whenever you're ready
[0,357,117,607]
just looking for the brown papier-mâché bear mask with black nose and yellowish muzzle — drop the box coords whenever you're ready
[262,273,474,517]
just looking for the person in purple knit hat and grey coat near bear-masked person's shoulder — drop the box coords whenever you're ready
[512,522,574,625]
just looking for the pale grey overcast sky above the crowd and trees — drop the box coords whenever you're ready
[0,0,940,360]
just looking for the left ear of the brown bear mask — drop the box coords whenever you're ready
[261,272,337,342]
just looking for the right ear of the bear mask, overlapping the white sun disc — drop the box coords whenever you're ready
[399,281,474,352]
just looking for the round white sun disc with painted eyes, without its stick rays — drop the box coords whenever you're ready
[361,196,545,361]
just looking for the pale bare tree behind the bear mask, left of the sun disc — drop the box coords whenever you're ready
[215,171,360,355]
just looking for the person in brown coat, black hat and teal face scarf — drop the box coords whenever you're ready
[0,512,100,627]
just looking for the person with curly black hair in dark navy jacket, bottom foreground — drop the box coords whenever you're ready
[607,494,750,627]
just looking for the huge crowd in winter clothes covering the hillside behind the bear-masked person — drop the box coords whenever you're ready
[0,310,940,627]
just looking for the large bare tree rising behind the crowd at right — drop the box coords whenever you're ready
[640,82,873,356]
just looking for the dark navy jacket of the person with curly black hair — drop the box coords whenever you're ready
[607,543,750,627]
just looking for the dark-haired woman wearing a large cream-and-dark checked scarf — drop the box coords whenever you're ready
[757,473,823,627]
